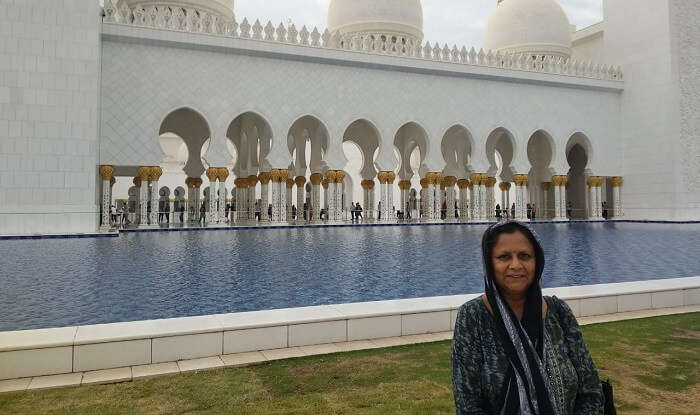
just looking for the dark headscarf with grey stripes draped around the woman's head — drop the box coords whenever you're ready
[481,220,556,415]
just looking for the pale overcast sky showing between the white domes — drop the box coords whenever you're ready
[235,0,603,46]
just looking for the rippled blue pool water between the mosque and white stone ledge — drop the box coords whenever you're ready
[0,223,700,331]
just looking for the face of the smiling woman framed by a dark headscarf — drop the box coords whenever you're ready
[491,231,536,296]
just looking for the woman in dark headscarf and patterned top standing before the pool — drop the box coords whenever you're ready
[452,221,603,415]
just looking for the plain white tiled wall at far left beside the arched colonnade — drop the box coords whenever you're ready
[0,0,101,234]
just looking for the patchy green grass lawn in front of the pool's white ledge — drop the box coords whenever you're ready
[0,313,700,415]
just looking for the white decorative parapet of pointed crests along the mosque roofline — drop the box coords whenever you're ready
[104,0,623,81]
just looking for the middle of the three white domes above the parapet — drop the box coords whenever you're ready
[328,0,423,42]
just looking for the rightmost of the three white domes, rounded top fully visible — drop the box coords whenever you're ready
[484,0,571,58]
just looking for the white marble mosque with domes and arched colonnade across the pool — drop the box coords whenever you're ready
[0,0,700,234]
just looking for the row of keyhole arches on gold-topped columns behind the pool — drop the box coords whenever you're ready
[95,108,623,227]
